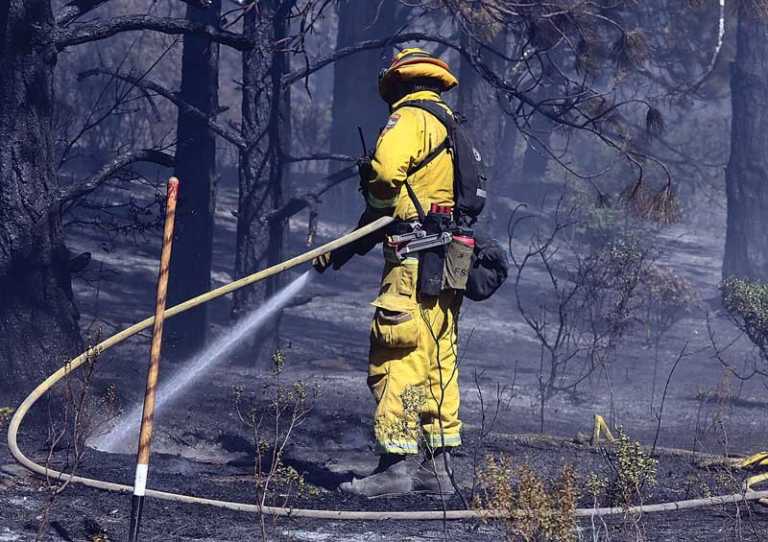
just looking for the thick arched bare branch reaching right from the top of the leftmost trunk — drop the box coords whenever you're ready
[54,15,254,51]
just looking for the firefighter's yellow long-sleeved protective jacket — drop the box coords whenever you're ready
[367,90,454,220]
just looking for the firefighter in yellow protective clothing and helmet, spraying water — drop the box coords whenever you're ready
[315,49,462,497]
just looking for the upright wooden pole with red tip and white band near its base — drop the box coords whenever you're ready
[129,177,179,542]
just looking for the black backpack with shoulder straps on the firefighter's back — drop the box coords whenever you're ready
[398,100,488,226]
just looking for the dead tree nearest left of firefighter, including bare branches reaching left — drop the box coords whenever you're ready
[81,0,340,364]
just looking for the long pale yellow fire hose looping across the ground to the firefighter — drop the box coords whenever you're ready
[8,217,768,521]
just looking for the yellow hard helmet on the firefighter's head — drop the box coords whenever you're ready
[379,47,459,103]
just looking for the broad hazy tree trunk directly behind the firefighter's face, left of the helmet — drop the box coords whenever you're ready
[327,0,397,220]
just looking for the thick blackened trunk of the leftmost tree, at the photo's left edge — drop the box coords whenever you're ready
[0,0,82,400]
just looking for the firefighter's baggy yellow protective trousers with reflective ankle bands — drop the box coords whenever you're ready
[368,258,461,454]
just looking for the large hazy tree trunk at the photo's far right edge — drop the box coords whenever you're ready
[723,6,768,281]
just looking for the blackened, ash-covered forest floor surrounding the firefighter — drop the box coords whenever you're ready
[0,188,768,541]
